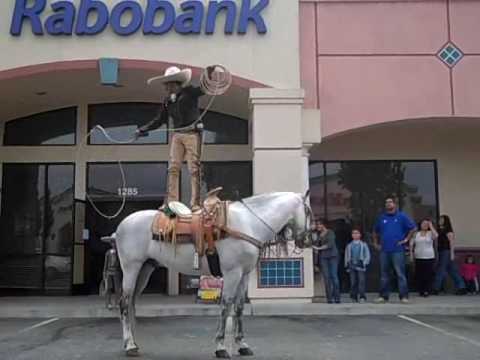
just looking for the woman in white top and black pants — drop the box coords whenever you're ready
[410,219,438,297]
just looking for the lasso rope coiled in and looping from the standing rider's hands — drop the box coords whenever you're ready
[85,65,232,221]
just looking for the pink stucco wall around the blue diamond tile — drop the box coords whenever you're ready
[300,0,480,137]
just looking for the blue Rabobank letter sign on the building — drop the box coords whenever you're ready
[10,0,270,36]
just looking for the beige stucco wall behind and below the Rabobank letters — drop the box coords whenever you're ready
[0,0,300,88]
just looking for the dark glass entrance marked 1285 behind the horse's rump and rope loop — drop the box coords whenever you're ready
[84,163,167,294]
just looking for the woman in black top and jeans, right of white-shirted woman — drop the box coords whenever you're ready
[432,215,467,295]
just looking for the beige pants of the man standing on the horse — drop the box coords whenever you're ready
[167,132,201,207]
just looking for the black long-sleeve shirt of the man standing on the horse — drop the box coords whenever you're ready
[139,86,205,132]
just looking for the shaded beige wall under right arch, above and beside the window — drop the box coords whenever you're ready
[311,118,480,247]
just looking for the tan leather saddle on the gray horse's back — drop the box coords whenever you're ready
[152,187,228,256]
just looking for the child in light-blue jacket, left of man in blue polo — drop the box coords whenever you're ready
[345,228,370,303]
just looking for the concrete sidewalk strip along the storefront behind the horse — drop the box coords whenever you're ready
[0,294,480,318]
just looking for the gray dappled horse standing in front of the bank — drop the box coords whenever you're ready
[114,192,312,358]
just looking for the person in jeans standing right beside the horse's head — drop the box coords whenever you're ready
[313,220,340,304]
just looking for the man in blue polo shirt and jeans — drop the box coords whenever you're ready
[373,197,416,303]
